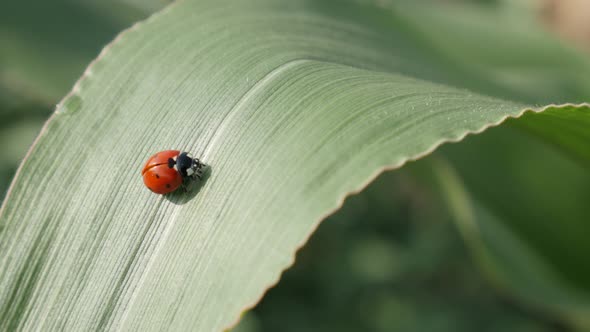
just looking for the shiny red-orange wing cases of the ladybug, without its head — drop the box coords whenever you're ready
[141,150,182,195]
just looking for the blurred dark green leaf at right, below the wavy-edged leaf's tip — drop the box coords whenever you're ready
[433,121,590,330]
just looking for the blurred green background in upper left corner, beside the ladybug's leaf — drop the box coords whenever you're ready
[0,0,164,198]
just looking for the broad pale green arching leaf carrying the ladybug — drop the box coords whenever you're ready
[0,0,588,331]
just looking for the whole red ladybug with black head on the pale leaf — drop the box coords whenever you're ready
[141,150,205,195]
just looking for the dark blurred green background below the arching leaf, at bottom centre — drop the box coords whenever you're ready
[236,162,569,332]
